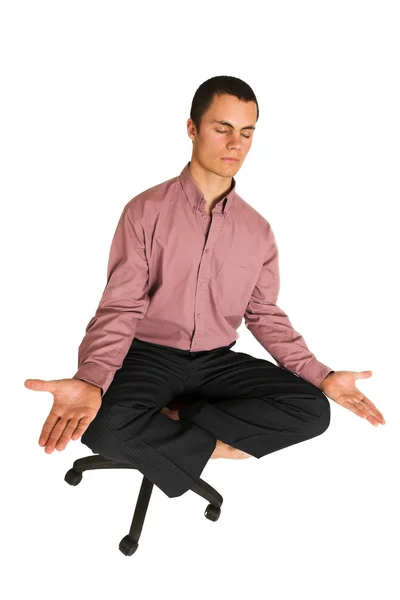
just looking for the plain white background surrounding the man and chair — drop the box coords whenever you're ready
[0,0,400,600]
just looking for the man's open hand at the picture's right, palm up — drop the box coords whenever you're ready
[319,371,386,426]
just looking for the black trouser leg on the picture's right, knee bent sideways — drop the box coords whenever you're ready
[179,350,330,458]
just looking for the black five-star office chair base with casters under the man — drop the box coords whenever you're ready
[64,400,223,556]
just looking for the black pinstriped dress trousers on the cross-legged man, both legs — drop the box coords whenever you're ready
[81,338,330,498]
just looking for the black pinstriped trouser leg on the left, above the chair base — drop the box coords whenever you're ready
[81,344,216,498]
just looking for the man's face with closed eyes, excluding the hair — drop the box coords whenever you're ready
[187,94,257,177]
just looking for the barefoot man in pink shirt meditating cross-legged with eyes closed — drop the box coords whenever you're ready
[25,76,385,497]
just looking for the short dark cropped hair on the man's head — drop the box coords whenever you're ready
[190,75,259,131]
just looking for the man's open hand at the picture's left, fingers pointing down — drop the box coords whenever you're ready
[24,379,101,454]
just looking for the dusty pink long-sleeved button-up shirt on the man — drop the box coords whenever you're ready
[74,162,332,396]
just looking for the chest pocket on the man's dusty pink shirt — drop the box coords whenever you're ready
[215,260,259,317]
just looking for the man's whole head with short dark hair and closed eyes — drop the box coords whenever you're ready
[187,75,259,177]
